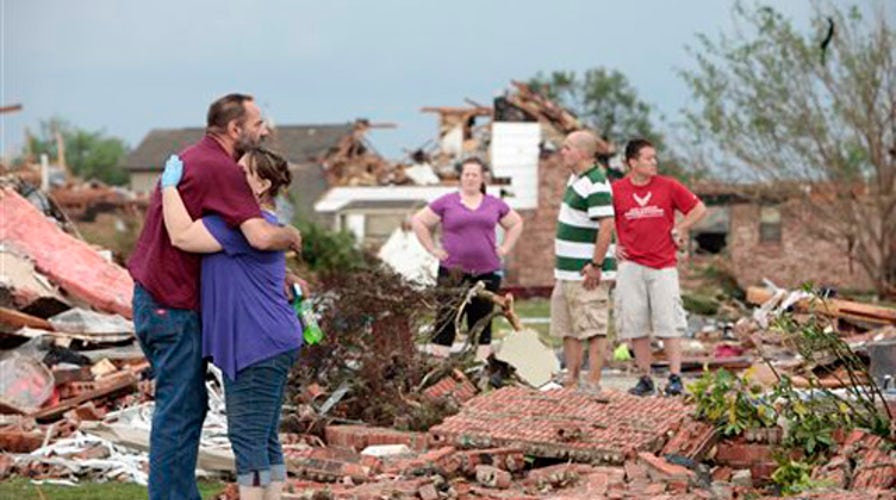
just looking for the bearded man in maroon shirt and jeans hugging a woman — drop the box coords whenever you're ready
[128,94,302,500]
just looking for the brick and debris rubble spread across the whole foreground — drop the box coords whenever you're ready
[0,175,896,499]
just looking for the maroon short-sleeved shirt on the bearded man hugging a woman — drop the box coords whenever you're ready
[128,136,261,311]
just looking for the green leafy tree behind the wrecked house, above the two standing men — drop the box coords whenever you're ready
[527,68,701,179]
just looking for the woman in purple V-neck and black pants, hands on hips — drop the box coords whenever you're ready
[411,157,523,359]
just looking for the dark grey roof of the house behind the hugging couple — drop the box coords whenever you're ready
[122,123,355,223]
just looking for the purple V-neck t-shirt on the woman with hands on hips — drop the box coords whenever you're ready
[429,193,510,274]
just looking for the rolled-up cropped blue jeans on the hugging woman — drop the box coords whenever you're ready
[224,349,299,486]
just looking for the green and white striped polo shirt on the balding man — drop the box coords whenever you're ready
[554,165,616,281]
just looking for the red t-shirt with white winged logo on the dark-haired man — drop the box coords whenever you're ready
[612,175,700,269]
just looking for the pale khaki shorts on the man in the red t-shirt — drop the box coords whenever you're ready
[613,261,688,340]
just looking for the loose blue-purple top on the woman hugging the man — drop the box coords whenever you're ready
[200,212,303,380]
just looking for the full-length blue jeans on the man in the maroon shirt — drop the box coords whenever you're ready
[133,284,208,500]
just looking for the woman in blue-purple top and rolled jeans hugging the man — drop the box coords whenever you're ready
[162,148,302,499]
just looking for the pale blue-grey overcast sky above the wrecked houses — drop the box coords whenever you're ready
[0,0,880,162]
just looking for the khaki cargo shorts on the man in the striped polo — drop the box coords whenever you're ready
[551,280,610,340]
